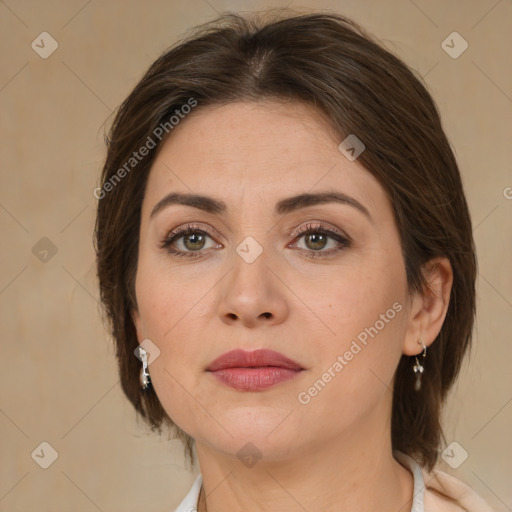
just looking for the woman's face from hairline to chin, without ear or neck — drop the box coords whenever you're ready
[134,101,420,459]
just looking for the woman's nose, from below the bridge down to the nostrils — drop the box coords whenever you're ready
[215,251,289,328]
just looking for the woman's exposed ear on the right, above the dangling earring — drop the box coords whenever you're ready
[402,257,453,356]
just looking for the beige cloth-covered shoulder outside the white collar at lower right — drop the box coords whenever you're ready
[422,469,494,512]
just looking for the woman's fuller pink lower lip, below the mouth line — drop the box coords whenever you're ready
[212,366,301,391]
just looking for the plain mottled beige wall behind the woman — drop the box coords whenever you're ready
[0,0,512,512]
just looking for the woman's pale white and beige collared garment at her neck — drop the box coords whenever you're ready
[174,452,493,512]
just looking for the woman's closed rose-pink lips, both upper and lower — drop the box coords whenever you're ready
[207,349,304,391]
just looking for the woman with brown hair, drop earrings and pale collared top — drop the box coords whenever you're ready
[96,10,490,512]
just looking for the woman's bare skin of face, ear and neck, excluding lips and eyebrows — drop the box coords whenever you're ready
[133,101,452,512]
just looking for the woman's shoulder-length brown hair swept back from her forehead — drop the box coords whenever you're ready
[95,14,476,469]
